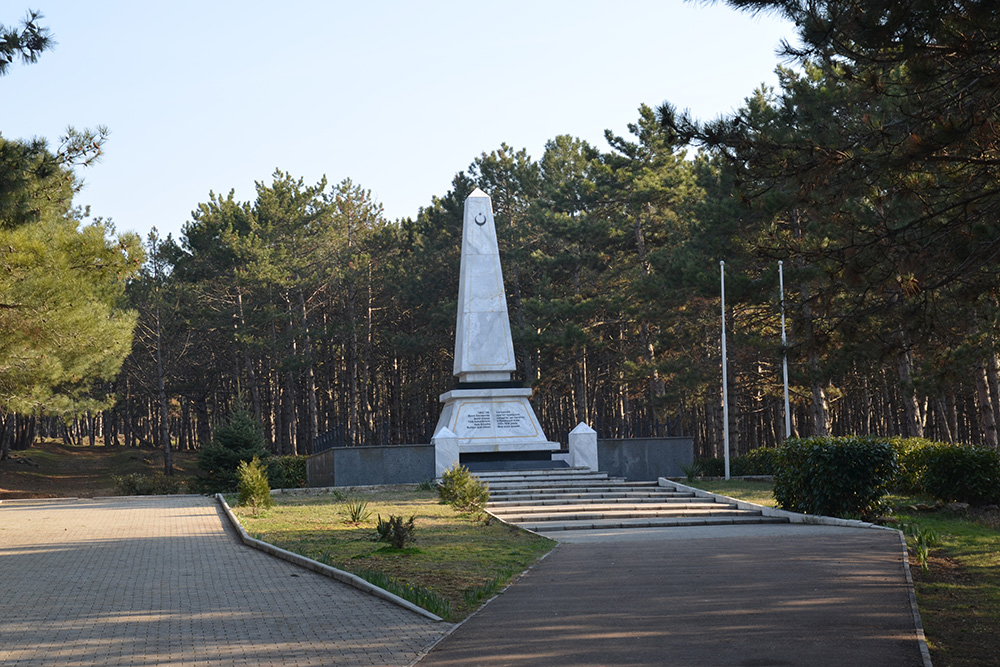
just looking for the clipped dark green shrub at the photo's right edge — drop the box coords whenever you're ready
[920,443,1000,505]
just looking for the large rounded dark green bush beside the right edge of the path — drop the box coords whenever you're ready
[774,437,897,518]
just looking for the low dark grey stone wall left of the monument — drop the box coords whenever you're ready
[306,445,435,486]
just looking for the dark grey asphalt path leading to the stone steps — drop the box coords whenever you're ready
[419,525,924,667]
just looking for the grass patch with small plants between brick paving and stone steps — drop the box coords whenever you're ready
[235,487,555,621]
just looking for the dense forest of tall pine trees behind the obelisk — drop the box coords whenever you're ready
[4,0,1000,470]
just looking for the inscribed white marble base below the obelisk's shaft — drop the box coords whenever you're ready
[434,387,559,454]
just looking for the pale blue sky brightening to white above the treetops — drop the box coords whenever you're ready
[0,0,794,243]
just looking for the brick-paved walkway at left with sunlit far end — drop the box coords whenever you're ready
[0,496,451,667]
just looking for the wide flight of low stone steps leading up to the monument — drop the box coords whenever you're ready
[475,468,785,532]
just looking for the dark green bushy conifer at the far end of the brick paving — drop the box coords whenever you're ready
[198,410,269,493]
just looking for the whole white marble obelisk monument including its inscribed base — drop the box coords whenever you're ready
[434,188,559,460]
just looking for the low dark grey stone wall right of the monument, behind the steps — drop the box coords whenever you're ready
[597,438,694,482]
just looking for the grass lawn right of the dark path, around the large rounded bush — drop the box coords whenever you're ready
[689,480,1000,667]
